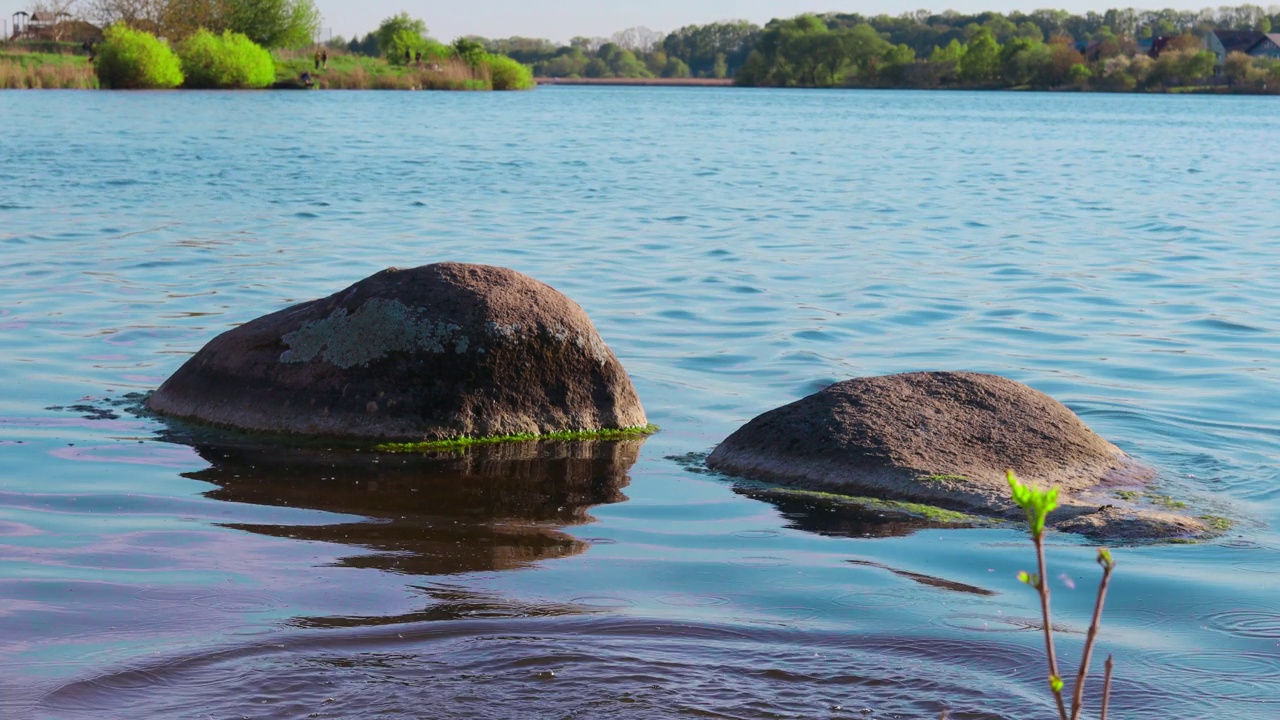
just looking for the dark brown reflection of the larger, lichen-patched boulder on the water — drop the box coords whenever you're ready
[187,439,643,575]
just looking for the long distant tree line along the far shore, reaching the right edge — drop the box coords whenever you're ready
[343,5,1280,90]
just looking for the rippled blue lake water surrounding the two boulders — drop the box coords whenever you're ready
[0,88,1280,720]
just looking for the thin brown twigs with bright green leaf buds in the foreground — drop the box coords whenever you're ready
[1005,470,1116,720]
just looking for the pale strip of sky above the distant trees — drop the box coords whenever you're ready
[0,0,1172,41]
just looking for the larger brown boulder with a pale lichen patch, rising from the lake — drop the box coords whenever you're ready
[147,263,648,442]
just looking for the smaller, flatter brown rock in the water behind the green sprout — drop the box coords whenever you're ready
[707,373,1204,539]
